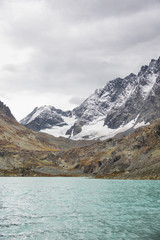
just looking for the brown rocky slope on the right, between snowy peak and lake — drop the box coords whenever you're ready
[57,120,160,179]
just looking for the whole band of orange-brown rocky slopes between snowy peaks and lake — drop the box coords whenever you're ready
[0,102,160,179]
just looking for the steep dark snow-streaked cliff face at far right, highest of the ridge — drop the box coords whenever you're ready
[105,58,160,128]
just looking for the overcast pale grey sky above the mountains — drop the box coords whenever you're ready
[0,0,160,120]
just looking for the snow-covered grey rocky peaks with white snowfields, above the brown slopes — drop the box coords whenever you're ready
[20,58,160,139]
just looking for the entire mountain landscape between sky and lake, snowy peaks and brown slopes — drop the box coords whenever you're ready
[0,58,160,179]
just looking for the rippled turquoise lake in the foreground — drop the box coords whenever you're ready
[0,177,160,240]
